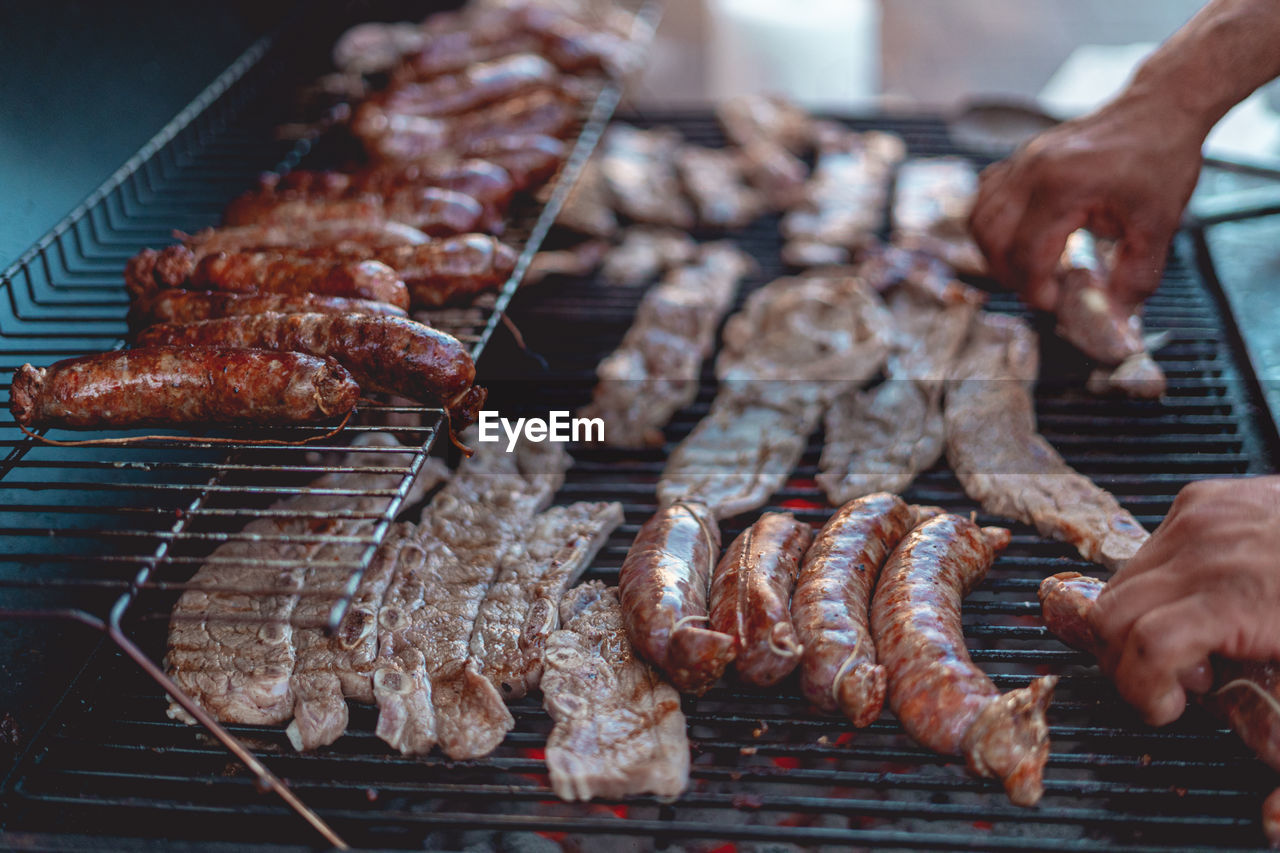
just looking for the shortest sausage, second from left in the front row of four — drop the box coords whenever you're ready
[710,512,813,686]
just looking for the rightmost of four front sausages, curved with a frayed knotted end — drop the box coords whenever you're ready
[872,515,1057,806]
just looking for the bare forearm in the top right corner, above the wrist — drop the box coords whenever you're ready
[1116,0,1280,138]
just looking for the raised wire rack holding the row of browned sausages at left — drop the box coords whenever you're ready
[0,3,660,847]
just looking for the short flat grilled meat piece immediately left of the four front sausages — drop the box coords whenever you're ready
[541,581,690,802]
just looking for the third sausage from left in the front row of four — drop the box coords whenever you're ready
[791,492,915,729]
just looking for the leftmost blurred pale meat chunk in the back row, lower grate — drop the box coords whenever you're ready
[600,124,696,231]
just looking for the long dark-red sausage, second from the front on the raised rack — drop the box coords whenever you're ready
[138,314,475,428]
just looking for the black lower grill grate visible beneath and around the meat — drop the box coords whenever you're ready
[0,114,1277,850]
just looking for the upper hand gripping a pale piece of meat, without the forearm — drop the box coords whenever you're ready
[969,95,1203,316]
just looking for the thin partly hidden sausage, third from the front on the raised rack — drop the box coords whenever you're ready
[129,287,407,329]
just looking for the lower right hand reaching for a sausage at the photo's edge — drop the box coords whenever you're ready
[1089,476,1280,725]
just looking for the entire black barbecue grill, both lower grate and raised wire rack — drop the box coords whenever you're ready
[0,16,1280,850]
